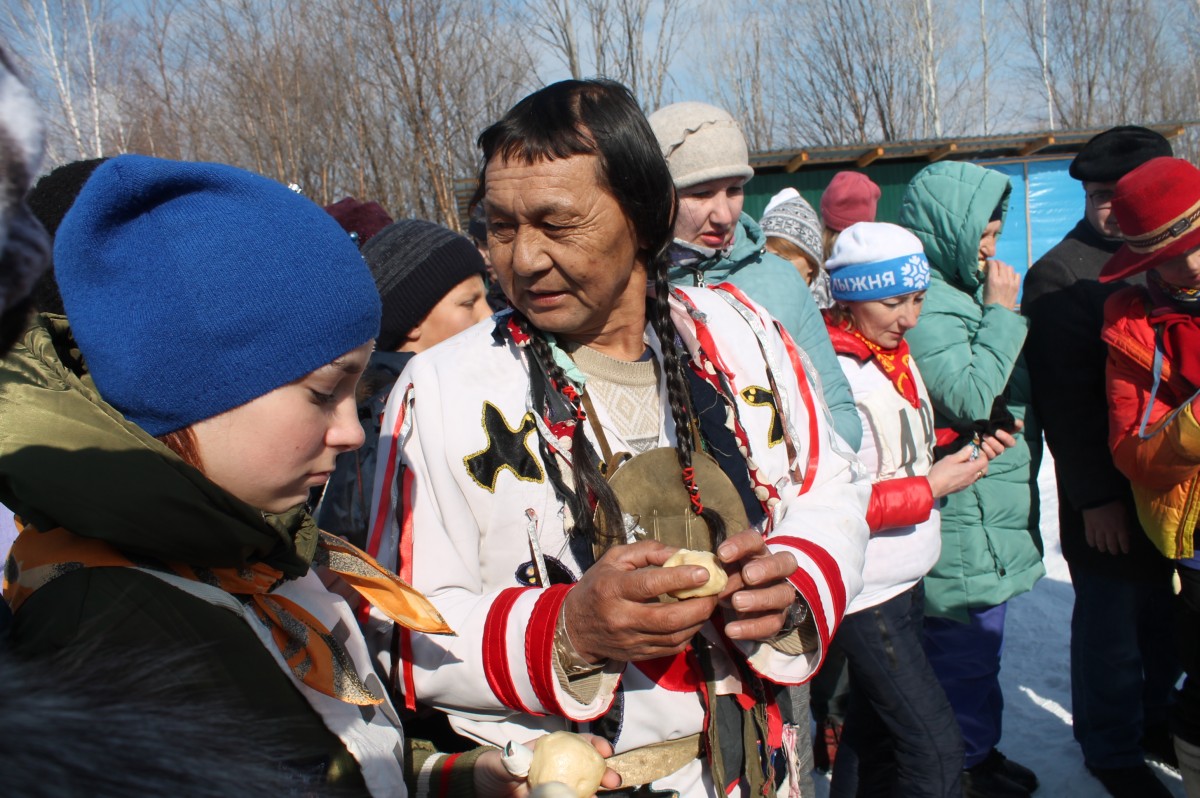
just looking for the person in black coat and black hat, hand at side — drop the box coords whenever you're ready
[1022,126,1178,798]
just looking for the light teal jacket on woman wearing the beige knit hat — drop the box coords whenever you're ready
[668,214,863,451]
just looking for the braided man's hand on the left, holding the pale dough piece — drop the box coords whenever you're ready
[564,540,715,662]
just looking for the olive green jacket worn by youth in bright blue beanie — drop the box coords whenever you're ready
[0,316,487,794]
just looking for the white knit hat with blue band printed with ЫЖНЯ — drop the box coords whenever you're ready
[826,222,930,302]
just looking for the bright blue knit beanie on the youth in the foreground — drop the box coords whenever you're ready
[54,155,380,436]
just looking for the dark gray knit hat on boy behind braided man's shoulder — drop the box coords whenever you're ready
[362,218,485,352]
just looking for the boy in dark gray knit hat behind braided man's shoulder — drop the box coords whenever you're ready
[316,218,491,547]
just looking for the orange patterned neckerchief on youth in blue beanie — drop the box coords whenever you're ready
[4,524,454,706]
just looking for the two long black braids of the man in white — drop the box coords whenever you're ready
[514,260,725,550]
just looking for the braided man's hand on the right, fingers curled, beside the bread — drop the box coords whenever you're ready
[716,529,798,640]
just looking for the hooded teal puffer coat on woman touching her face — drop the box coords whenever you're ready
[900,163,1045,622]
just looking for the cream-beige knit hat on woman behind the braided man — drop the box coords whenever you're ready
[650,102,754,188]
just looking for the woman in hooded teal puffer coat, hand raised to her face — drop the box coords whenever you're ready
[900,163,1045,797]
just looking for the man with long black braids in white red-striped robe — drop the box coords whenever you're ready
[368,80,869,796]
